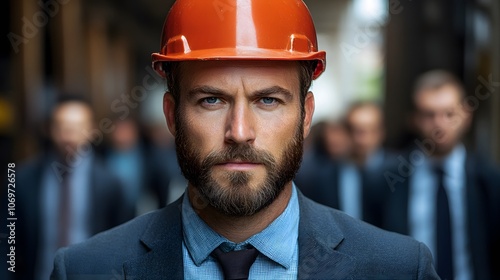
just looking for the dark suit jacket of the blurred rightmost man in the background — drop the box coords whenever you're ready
[377,153,500,279]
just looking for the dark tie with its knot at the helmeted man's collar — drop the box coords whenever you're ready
[212,247,259,280]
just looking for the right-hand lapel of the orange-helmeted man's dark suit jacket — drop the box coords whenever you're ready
[298,192,356,279]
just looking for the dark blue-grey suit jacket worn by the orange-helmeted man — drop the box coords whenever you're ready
[51,192,439,280]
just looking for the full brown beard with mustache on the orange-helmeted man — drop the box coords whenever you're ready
[175,116,304,217]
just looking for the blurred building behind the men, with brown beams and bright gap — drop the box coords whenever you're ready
[0,0,500,166]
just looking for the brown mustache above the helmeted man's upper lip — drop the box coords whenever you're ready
[202,144,276,168]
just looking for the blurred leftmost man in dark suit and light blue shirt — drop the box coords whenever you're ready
[11,95,132,280]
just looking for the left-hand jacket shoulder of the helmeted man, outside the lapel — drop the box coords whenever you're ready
[51,200,182,279]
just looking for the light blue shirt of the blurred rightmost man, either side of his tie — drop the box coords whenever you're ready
[408,145,472,280]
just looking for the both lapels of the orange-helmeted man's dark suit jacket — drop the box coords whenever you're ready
[123,192,357,279]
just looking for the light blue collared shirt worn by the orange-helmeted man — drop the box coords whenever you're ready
[182,185,299,280]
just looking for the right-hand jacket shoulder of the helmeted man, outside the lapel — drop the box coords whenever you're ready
[301,198,437,279]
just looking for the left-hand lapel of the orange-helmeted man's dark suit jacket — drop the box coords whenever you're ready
[123,197,184,279]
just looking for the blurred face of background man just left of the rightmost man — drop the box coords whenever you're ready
[347,106,384,158]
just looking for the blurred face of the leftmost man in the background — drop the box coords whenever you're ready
[50,102,93,159]
